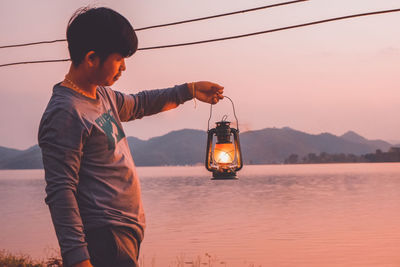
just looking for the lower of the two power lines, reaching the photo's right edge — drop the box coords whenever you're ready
[0,8,400,67]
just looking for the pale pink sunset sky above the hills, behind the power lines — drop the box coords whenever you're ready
[0,0,400,149]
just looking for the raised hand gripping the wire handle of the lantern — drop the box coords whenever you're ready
[189,81,224,104]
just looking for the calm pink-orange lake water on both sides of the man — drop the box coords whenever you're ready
[0,163,400,267]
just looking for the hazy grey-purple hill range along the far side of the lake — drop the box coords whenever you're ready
[0,127,391,169]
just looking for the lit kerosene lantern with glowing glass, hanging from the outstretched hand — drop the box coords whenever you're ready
[206,96,243,180]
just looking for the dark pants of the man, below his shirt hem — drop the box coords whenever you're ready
[86,226,140,267]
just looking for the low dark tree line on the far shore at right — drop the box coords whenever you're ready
[284,147,400,164]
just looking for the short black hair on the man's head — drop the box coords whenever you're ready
[67,7,138,66]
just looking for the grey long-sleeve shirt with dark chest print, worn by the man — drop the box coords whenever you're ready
[38,84,192,266]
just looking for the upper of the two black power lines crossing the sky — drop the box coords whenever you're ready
[0,0,309,49]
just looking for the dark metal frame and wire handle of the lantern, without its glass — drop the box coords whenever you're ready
[205,96,243,180]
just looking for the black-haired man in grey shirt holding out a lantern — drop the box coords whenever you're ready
[38,8,223,267]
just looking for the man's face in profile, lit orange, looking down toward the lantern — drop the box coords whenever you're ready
[96,53,126,86]
